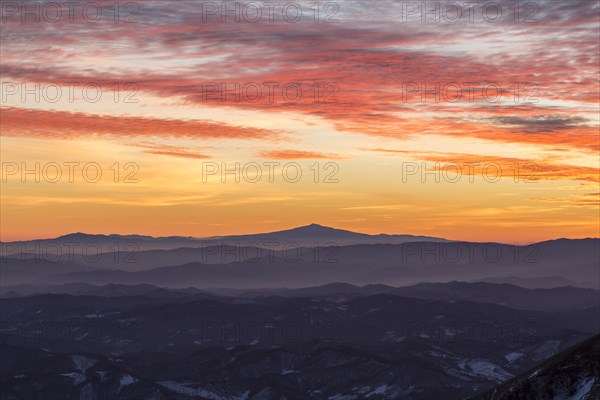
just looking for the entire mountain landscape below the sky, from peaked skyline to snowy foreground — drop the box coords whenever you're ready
[0,224,600,400]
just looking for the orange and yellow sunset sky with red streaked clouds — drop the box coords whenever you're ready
[0,0,600,244]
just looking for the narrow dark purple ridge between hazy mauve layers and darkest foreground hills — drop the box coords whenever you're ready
[0,281,600,318]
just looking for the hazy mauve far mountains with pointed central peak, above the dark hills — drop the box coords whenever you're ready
[0,224,600,289]
